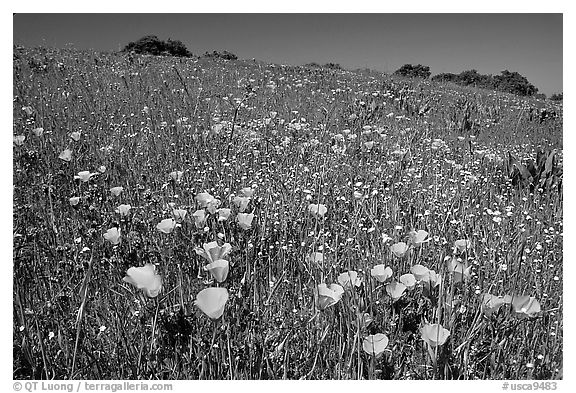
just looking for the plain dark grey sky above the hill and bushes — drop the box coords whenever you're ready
[14,14,563,95]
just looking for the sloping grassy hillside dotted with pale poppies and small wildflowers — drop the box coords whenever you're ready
[13,48,563,379]
